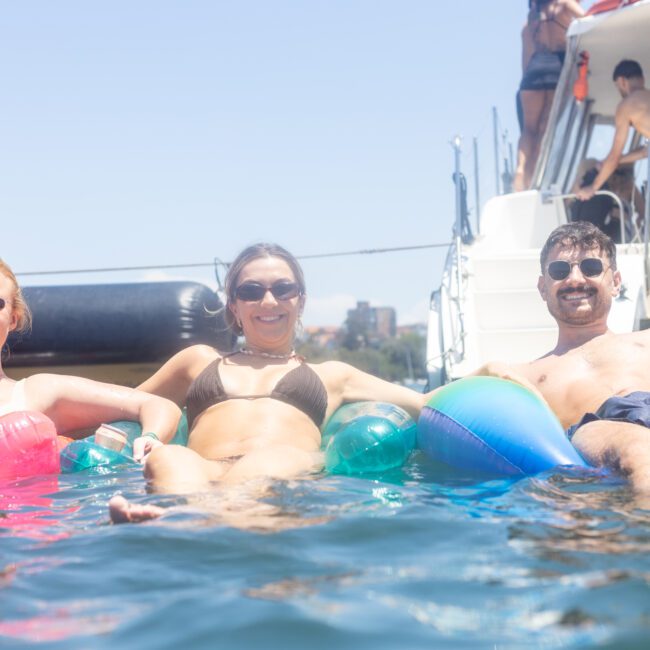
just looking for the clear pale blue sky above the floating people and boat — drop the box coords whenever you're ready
[0,0,591,325]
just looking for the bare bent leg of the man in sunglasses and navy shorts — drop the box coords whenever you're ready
[571,420,650,494]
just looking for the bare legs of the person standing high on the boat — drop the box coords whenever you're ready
[513,90,555,192]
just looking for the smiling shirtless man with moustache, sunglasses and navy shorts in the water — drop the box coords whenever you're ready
[476,221,650,493]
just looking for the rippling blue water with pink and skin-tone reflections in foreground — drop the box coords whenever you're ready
[0,454,650,650]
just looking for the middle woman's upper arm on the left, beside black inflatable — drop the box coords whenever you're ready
[138,345,218,407]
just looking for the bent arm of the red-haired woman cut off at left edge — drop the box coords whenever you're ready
[25,374,181,442]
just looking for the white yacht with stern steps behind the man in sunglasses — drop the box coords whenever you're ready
[427,0,650,387]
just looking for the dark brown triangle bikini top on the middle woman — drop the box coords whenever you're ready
[185,357,327,431]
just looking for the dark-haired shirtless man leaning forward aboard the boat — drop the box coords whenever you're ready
[576,60,650,201]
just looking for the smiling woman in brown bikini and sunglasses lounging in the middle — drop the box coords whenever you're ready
[110,244,427,521]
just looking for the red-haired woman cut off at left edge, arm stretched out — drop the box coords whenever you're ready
[0,260,181,460]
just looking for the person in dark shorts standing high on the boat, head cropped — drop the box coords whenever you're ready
[514,0,585,192]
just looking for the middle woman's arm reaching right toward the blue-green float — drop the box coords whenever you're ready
[322,361,427,420]
